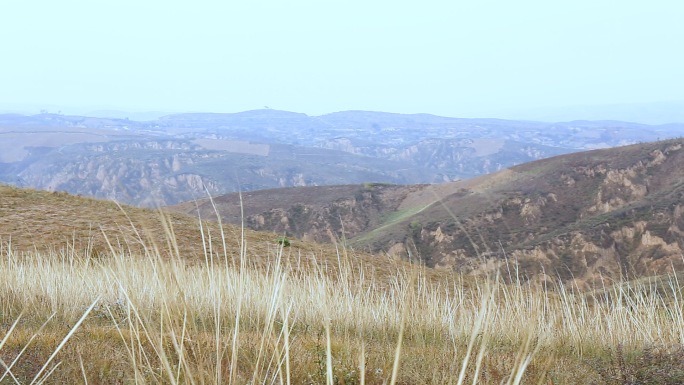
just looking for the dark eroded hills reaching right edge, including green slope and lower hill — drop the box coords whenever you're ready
[170,139,684,285]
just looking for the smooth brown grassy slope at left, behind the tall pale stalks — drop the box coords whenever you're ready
[0,185,448,281]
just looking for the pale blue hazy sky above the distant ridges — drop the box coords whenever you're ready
[0,0,684,116]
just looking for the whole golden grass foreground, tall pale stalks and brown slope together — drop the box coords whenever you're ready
[0,187,684,384]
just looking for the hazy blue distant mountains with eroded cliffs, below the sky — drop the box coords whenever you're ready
[0,109,684,206]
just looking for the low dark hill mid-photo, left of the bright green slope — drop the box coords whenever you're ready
[165,183,425,243]
